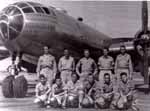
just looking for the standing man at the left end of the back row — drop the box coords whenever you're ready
[36,46,57,85]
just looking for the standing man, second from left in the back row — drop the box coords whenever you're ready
[58,49,75,85]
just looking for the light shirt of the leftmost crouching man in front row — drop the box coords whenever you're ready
[35,82,51,96]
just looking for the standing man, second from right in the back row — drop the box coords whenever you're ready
[98,48,114,84]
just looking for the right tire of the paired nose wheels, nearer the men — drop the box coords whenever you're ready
[13,76,28,98]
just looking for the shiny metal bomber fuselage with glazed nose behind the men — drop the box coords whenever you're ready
[0,2,111,64]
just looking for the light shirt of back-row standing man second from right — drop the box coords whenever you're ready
[98,56,114,69]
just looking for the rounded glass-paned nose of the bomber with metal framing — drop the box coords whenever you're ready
[0,5,24,41]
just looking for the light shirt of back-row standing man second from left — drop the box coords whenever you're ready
[58,56,75,71]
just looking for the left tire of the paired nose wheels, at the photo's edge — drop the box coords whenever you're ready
[2,75,14,98]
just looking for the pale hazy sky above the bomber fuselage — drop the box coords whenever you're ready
[0,0,150,38]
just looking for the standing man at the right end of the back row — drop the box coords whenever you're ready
[115,45,133,80]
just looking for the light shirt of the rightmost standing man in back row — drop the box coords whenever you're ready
[115,53,133,73]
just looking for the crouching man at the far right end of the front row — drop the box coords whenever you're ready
[112,72,136,110]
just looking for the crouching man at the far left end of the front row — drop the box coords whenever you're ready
[34,75,51,106]
